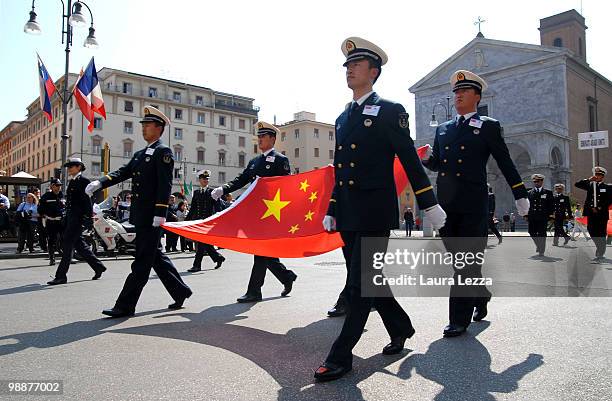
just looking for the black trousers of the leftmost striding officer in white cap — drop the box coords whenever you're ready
[55,219,106,279]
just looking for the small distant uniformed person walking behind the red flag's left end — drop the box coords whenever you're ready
[186,170,225,273]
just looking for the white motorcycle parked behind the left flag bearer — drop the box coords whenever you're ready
[86,197,136,256]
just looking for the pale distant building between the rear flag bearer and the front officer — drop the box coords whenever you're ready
[275,111,336,174]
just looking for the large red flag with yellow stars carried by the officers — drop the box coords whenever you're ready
[163,146,427,258]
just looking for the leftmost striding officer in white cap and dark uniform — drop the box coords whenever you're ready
[47,157,106,285]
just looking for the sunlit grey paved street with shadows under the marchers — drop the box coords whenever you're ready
[0,238,612,401]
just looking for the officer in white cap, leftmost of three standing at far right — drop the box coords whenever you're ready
[527,174,553,256]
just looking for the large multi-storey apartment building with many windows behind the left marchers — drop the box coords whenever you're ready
[0,68,258,194]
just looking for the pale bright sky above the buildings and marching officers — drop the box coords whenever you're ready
[0,0,612,135]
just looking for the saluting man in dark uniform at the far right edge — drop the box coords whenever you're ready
[576,166,612,261]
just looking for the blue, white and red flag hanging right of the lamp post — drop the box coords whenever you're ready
[73,57,106,132]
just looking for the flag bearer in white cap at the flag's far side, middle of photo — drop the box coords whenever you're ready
[211,121,297,303]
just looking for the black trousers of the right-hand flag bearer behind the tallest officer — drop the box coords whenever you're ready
[440,213,491,327]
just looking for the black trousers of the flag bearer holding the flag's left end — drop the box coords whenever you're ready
[115,226,192,311]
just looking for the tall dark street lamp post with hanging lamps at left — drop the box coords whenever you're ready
[23,0,98,182]
